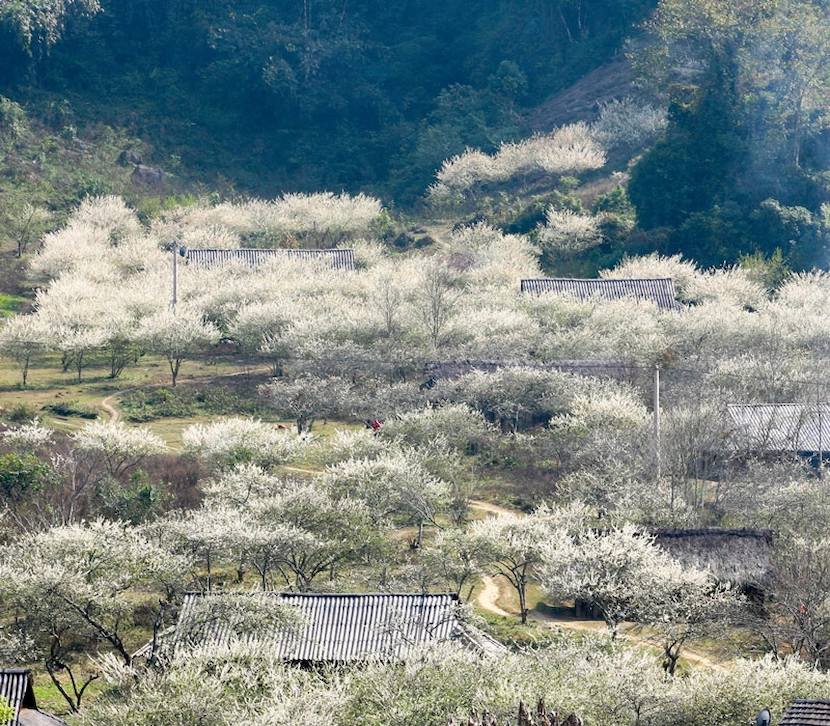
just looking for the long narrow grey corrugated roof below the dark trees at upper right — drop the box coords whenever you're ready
[522,277,680,310]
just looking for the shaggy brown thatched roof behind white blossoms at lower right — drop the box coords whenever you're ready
[652,527,772,586]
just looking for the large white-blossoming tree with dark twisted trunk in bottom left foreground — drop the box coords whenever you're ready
[0,520,188,711]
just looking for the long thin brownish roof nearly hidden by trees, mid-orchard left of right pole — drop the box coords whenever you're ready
[424,360,641,383]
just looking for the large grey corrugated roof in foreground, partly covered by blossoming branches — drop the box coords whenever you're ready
[169,593,503,662]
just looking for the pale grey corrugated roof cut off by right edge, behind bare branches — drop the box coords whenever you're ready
[727,403,830,453]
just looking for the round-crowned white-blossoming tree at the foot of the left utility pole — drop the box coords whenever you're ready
[136,305,220,386]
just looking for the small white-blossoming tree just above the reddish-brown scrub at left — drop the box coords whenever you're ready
[70,421,167,478]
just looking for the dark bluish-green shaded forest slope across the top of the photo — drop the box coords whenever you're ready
[0,0,654,201]
